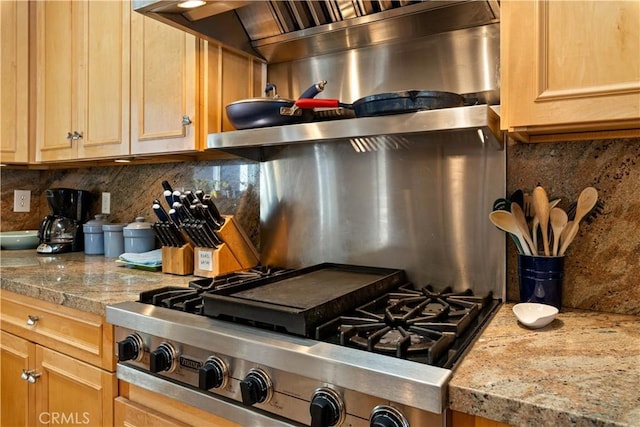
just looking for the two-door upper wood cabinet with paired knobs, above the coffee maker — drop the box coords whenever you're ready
[34,0,131,161]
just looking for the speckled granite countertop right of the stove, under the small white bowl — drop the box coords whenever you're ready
[449,304,640,426]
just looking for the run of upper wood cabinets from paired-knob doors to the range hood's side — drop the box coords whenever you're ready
[32,0,266,163]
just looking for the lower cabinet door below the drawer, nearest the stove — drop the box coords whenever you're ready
[35,345,118,426]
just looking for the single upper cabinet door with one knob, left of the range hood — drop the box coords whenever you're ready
[131,13,200,154]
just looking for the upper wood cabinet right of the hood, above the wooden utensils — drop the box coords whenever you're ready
[501,0,640,141]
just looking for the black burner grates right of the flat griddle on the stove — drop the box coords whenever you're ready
[316,284,493,365]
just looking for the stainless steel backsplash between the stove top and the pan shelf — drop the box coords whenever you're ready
[260,134,506,296]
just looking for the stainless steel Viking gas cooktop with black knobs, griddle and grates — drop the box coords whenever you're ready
[107,263,500,426]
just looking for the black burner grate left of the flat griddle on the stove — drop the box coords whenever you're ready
[139,265,291,315]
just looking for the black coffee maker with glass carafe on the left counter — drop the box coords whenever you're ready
[36,188,91,254]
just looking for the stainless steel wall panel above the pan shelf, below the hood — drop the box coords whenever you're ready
[267,24,500,104]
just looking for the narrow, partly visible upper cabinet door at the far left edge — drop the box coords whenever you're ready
[0,1,29,163]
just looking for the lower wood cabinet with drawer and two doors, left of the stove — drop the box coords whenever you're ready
[0,291,118,426]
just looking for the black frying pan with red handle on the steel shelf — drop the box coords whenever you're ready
[295,90,468,117]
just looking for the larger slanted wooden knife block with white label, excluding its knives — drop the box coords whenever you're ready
[193,216,260,277]
